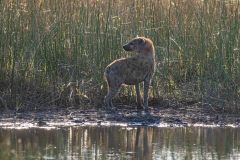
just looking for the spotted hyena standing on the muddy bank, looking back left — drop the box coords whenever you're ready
[104,37,155,110]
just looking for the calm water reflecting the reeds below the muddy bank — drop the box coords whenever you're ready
[0,126,240,160]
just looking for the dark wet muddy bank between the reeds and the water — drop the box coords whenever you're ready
[0,105,240,128]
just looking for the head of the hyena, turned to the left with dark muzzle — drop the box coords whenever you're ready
[123,37,153,53]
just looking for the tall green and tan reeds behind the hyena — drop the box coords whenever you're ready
[0,0,240,112]
